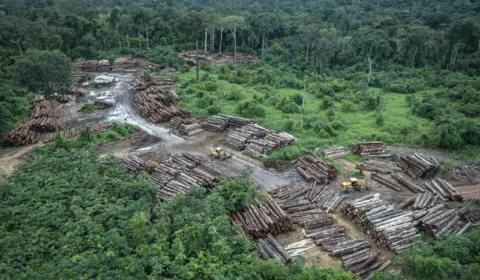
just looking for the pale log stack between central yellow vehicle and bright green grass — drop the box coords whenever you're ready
[226,124,296,158]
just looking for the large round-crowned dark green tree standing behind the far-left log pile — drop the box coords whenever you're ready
[14,49,73,132]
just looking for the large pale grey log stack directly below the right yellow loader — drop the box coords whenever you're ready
[342,194,420,253]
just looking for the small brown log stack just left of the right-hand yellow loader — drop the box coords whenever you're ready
[295,156,337,184]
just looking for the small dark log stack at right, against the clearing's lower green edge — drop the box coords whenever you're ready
[398,153,442,179]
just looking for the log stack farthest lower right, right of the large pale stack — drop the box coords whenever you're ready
[413,204,473,237]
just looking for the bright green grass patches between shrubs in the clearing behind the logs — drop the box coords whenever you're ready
[176,68,434,159]
